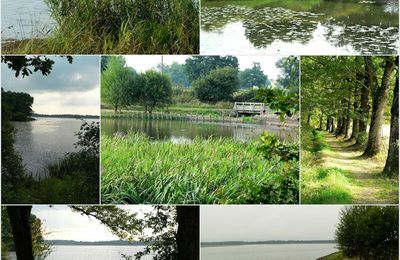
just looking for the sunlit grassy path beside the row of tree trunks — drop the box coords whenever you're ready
[301,127,398,204]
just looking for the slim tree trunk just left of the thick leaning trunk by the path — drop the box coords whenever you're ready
[356,65,372,145]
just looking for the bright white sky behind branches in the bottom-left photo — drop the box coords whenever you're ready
[32,206,156,241]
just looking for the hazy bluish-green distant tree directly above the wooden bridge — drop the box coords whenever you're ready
[239,62,271,88]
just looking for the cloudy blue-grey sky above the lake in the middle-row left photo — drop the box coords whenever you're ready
[1,56,100,115]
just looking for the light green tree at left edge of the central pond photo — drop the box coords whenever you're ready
[101,56,136,112]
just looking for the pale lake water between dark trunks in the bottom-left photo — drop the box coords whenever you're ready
[11,246,153,260]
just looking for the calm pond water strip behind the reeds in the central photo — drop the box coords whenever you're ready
[101,118,297,143]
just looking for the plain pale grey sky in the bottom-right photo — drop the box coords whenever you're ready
[200,205,342,242]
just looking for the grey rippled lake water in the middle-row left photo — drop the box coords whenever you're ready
[13,117,97,178]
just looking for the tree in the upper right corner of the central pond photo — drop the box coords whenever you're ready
[276,56,300,92]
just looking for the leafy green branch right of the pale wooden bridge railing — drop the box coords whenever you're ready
[258,88,299,121]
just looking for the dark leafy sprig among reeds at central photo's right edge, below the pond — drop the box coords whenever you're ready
[257,131,299,162]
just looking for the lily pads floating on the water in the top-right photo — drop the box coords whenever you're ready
[201,1,399,54]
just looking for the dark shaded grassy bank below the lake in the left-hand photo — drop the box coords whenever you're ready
[2,152,99,204]
